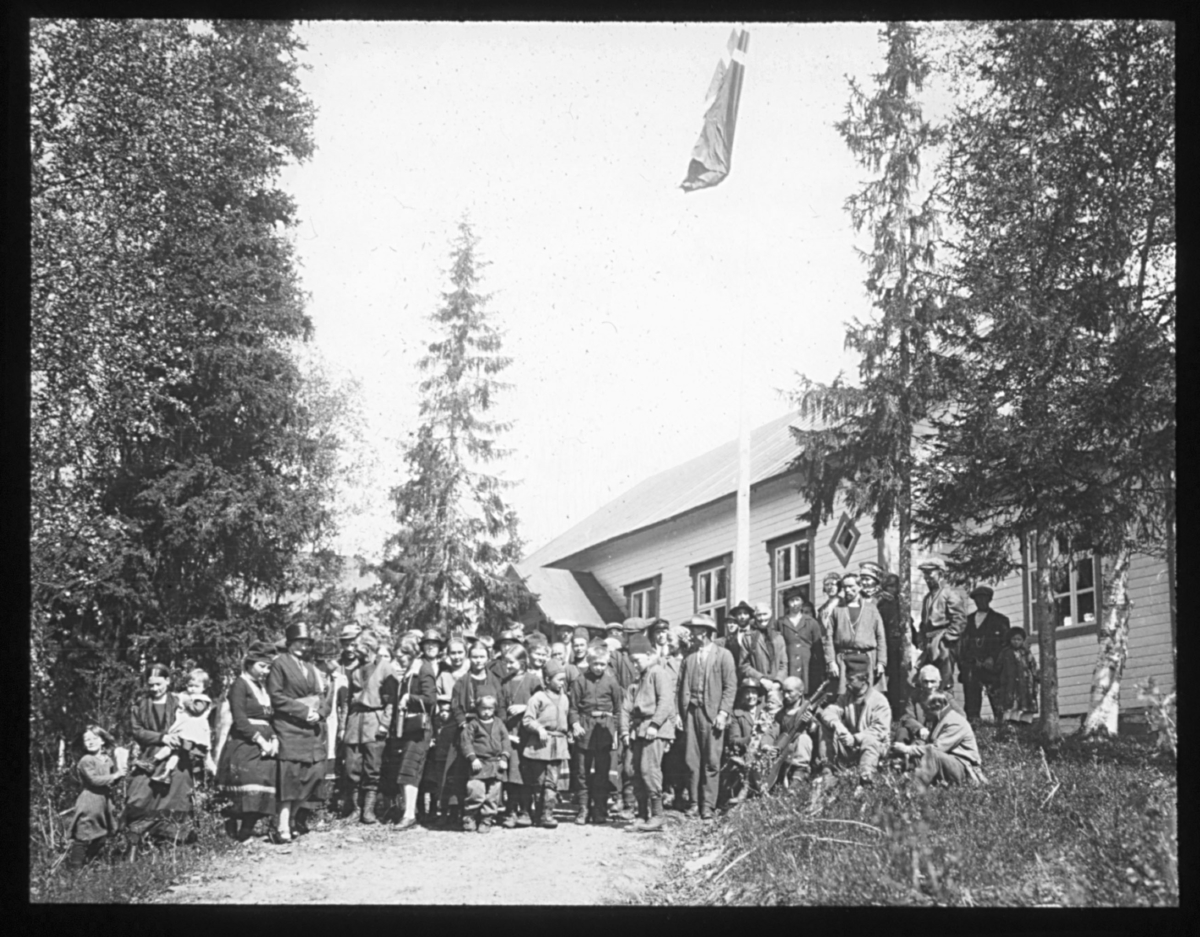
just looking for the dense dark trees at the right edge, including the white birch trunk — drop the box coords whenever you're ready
[919,22,1175,741]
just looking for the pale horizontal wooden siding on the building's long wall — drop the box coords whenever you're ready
[551,477,1174,716]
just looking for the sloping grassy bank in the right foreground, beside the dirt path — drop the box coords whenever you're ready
[653,725,1180,907]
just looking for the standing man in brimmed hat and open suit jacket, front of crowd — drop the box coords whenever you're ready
[676,615,738,819]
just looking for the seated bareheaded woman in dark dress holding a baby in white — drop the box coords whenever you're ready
[121,663,196,849]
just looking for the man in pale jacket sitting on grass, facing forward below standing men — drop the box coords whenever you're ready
[818,654,892,786]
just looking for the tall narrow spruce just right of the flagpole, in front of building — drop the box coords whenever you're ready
[793,23,944,645]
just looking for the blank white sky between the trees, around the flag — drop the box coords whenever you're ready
[278,22,926,555]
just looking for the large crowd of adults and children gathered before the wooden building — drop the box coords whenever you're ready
[63,560,1037,864]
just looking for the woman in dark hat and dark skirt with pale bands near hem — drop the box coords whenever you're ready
[217,641,280,842]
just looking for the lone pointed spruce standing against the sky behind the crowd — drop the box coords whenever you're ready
[377,220,527,631]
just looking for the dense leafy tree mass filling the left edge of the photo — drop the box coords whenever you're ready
[30,19,330,758]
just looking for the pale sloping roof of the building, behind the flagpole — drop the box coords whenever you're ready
[517,412,812,571]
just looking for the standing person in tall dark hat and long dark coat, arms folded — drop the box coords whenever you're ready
[266,621,334,843]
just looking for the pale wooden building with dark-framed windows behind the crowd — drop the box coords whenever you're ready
[516,413,1174,717]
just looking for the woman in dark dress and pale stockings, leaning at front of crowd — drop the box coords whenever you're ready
[383,627,443,830]
